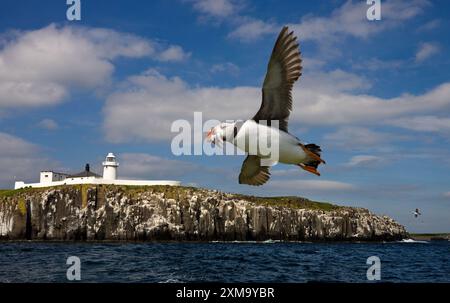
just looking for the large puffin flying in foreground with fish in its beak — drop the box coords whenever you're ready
[207,26,325,186]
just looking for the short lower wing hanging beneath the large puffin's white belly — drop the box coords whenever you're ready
[239,155,270,186]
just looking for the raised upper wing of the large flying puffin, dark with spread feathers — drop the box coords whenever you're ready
[253,26,302,132]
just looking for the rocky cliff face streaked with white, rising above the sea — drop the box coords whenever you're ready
[0,185,407,241]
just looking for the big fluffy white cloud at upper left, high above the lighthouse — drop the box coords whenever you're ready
[0,24,189,107]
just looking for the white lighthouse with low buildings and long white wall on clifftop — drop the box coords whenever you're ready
[14,153,180,189]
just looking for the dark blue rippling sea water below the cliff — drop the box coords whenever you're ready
[0,241,450,283]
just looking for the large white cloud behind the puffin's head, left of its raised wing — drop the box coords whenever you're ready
[103,70,260,142]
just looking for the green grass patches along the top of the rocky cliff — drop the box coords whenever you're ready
[0,185,341,211]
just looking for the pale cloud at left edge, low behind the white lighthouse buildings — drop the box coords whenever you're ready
[0,132,56,188]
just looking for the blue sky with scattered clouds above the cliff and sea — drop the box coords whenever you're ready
[0,0,450,232]
